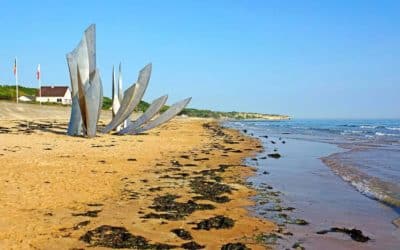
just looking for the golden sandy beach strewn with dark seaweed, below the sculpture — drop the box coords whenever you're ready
[0,115,276,249]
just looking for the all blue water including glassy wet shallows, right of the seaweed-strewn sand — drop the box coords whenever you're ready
[224,119,400,249]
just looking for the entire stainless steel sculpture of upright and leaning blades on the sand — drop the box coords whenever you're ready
[67,24,191,137]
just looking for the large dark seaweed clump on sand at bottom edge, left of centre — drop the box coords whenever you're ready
[80,225,176,249]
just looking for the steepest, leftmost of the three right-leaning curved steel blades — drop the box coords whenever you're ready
[102,64,152,133]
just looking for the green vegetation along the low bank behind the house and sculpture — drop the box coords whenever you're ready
[0,85,289,120]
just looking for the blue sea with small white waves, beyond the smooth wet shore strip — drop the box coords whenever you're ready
[229,119,400,211]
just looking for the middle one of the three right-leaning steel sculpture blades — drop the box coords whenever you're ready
[119,95,168,134]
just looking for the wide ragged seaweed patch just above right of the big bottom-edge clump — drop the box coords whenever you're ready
[142,194,215,220]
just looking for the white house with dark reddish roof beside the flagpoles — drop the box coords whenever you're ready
[36,86,72,105]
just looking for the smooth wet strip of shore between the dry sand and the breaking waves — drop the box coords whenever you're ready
[225,120,400,249]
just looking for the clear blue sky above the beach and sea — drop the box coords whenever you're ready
[0,0,400,119]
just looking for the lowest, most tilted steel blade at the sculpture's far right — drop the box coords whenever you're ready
[123,97,192,134]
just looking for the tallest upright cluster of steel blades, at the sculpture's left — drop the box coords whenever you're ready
[67,24,103,137]
